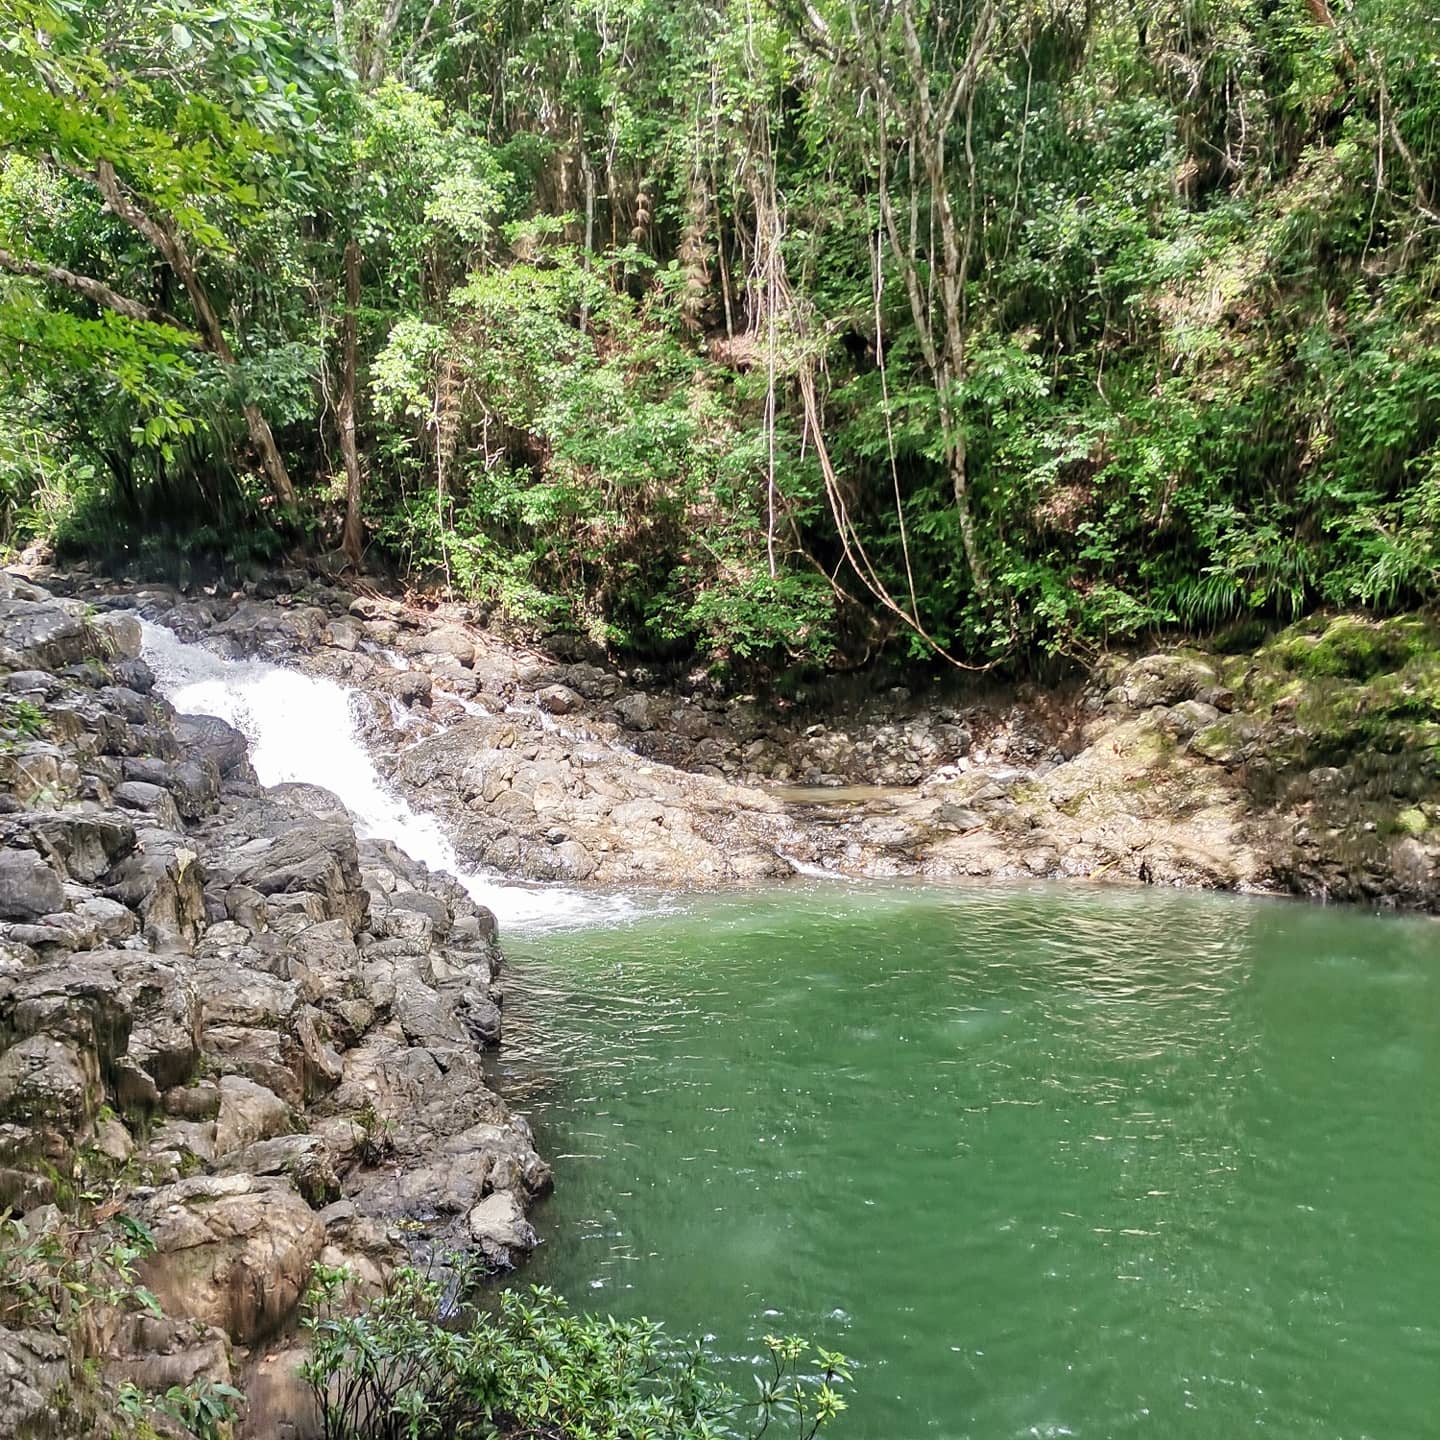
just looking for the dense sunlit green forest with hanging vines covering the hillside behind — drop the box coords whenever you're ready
[0,0,1440,662]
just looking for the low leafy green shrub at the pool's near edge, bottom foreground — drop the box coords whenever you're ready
[302,1267,850,1440]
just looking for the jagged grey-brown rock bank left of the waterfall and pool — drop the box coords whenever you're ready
[0,575,550,1440]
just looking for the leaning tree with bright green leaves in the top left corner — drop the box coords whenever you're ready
[0,0,341,508]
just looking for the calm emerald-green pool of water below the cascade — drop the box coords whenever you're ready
[501,884,1440,1440]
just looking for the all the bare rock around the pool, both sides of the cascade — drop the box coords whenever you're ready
[0,561,1440,1437]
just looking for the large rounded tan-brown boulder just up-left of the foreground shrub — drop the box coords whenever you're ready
[137,1175,325,1345]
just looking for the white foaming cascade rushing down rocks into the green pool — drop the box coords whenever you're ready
[143,621,638,933]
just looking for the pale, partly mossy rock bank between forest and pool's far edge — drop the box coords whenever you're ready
[47,564,1440,910]
